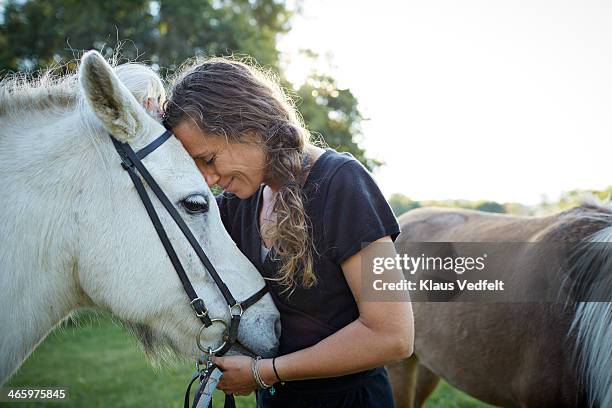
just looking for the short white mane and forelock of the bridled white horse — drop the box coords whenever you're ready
[0,56,166,119]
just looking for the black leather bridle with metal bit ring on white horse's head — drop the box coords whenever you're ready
[110,131,268,356]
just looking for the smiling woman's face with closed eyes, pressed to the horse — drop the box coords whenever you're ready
[173,121,266,199]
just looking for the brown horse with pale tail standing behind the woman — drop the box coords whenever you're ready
[388,202,612,407]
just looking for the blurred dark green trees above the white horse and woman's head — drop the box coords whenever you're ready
[0,0,291,71]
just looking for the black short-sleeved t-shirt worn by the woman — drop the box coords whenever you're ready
[217,149,400,355]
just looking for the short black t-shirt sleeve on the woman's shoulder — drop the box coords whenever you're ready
[323,160,400,264]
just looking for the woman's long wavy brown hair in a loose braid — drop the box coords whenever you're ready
[163,58,317,288]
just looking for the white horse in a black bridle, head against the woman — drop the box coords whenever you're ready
[0,52,279,384]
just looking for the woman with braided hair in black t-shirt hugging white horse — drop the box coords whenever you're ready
[164,59,413,407]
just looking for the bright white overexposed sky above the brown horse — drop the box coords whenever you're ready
[280,0,612,205]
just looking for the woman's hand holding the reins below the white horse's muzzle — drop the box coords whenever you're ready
[213,356,257,395]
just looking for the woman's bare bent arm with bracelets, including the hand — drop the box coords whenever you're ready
[215,237,414,394]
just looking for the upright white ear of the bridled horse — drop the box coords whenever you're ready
[79,51,144,142]
